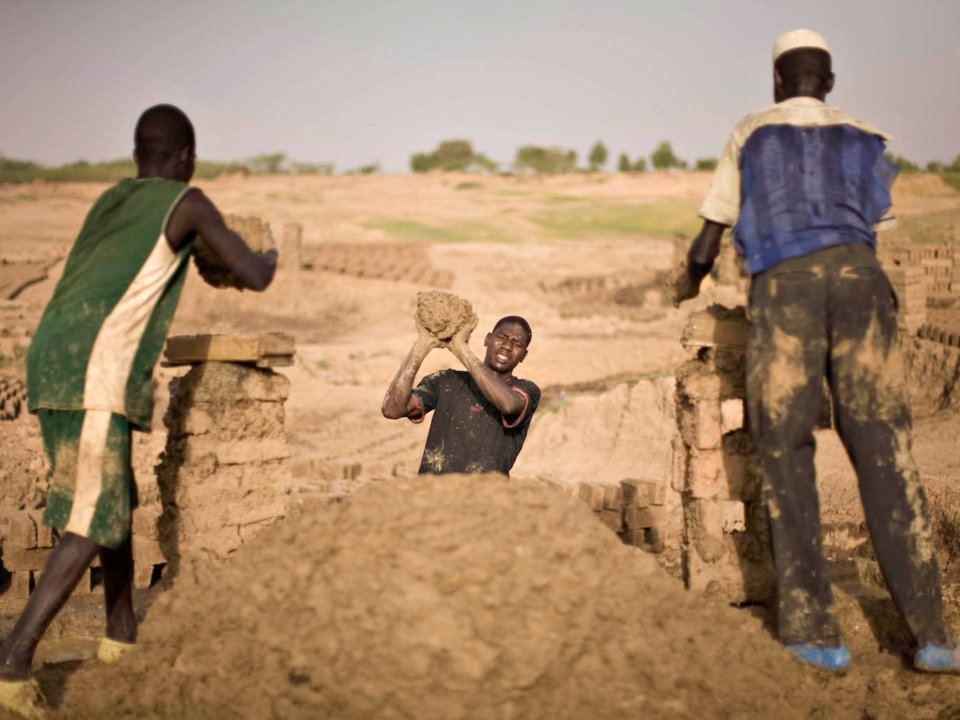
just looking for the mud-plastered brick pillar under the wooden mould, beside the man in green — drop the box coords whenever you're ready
[157,362,292,574]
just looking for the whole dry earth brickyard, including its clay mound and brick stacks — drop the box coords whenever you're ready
[0,173,960,720]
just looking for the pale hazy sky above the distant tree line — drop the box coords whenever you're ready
[0,0,960,172]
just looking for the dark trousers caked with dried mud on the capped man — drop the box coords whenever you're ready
[747,243,946,645]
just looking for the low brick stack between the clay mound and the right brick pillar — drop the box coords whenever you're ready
[575,478,667,552]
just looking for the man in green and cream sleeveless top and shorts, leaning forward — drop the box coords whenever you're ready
[0,105,277,717]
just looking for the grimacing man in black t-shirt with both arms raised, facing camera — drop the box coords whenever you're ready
[382,306,540,475]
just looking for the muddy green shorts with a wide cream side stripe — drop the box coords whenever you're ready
[37,410,137,548]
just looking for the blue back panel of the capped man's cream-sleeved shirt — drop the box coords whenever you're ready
[733,125,897,275]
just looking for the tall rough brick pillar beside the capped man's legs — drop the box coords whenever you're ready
[672,306,774,603]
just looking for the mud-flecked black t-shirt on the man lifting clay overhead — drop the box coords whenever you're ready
[410,370,540,475]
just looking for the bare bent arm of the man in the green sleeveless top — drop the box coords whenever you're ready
[167,193,277,290]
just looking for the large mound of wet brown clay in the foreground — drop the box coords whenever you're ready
[59,475,859,720]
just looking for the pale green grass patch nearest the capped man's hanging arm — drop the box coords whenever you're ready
[533,201,701,240]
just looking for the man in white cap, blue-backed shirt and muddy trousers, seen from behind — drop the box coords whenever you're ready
[674,30,960,672]
